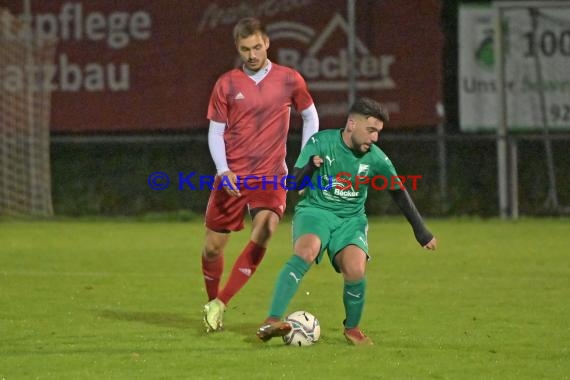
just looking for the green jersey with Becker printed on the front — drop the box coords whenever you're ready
[295,129,399,217]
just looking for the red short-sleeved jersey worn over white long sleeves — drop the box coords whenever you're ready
[208,62,313,176]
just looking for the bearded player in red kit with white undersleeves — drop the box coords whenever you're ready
[202,18,319,331]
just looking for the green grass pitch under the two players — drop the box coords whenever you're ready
[0,218,570,380]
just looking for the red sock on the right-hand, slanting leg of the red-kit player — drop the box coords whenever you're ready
[218,241,266,305]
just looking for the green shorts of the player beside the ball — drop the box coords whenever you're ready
[293,207,369,273]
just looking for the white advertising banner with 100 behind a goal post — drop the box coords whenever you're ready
[458,3,570,132]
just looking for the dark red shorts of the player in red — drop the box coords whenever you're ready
[206,177,287,231]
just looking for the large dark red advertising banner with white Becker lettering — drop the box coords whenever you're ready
[0,0,443,132]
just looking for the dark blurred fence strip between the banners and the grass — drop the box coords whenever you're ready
[52,132,570,216]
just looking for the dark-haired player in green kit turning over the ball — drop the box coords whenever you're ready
[257,98,437,345]
